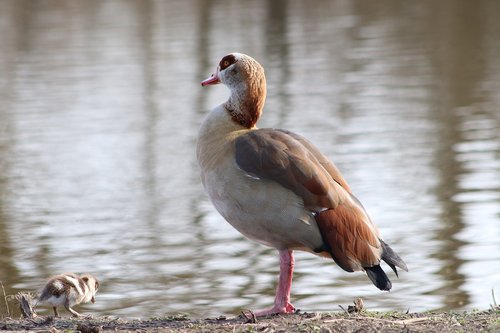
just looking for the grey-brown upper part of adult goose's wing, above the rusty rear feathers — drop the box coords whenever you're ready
[235,129,338,210]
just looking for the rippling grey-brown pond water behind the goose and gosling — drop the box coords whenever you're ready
[0,0,500,317]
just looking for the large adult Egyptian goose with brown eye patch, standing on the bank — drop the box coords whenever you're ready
[197,53,407,316]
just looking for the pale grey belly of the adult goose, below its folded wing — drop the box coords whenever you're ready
[202,161,323,251]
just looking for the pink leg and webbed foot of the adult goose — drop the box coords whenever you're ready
[254,250,295,317]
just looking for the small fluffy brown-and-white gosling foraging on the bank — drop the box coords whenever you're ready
[37,273,99,317]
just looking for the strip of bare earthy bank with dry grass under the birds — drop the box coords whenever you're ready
[0,294,500,333]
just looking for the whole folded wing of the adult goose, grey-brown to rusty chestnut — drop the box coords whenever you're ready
[235,129,394,272]
